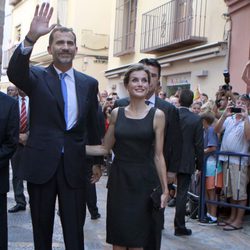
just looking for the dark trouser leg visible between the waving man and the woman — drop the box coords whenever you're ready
[86,163,98,216]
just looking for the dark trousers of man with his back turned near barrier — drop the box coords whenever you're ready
[174,173,191,229]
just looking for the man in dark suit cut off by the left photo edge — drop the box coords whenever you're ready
[0,92,19,250]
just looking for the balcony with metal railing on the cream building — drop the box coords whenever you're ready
[140,0,207,53]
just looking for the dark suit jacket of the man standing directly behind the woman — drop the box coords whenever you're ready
[114,97,182,172]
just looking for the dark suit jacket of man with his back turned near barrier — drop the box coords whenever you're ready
[177,107,204,174]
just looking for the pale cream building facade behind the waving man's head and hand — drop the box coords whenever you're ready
[0,0,111,91]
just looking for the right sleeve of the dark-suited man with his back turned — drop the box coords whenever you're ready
[194,119,204,170]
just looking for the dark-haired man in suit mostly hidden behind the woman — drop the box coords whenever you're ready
[114,58,181,250]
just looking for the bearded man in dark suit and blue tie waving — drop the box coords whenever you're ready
[7,3,101,250]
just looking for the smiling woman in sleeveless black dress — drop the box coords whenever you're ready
[86,64,168,250]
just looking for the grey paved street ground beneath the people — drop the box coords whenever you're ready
[8,177,250,250]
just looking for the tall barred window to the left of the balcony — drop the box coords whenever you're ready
[114,0,137,56]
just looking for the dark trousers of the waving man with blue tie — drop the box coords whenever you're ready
[27,157,86,250]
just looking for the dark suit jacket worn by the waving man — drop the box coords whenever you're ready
[7,46,101,188]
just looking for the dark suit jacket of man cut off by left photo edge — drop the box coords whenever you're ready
[0,92,19,194]
